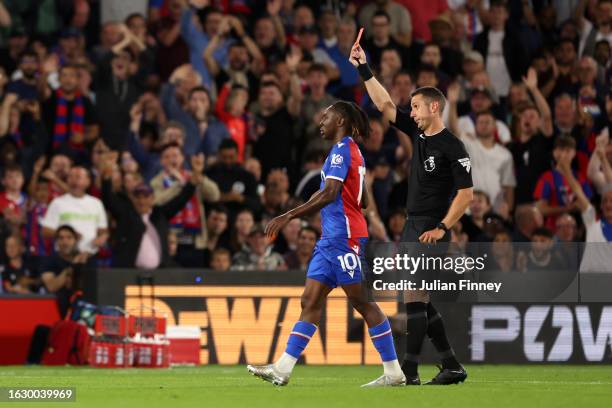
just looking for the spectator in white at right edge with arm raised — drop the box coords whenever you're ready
[559,155,612,272]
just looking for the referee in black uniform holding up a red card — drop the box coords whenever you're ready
[349,44,473,385]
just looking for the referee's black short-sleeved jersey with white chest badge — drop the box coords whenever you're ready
[391,108,473,220]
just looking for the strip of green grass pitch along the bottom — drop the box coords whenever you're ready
[0,365,612,408]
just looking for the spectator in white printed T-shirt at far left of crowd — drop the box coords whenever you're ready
[41,166,108,255]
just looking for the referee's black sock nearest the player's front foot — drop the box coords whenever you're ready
[402,302,427,377]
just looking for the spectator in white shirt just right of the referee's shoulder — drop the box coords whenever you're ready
[459,112,516,212]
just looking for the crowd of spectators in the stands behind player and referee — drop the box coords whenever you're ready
[0,0,612,293]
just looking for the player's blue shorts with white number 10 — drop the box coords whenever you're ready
[306,238,368,288]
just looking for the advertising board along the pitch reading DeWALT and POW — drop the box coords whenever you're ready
[90,269,612,364]
